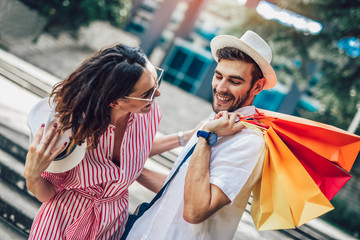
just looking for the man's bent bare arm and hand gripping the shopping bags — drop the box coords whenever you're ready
[183,112,244,224]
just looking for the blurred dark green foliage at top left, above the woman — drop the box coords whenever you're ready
[21,0,131,32]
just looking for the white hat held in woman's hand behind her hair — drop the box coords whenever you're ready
[27,98,87,173]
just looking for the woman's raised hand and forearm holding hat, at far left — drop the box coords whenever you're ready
[24,124,66,202]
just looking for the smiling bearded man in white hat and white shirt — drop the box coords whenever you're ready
[127,31,277,240]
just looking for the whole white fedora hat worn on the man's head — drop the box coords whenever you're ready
[210,31,277,89]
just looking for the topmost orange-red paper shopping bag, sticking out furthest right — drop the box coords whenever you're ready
[258,109,360,172]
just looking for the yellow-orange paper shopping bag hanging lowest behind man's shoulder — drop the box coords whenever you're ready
[251,127,333,230]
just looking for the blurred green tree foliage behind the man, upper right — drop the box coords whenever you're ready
[225,0,360,134]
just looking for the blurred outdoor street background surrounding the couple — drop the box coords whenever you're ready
[0,0,360,240]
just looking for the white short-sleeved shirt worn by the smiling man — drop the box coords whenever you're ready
[127,106,265,240]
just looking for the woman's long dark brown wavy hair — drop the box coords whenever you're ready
[50,44,148,148]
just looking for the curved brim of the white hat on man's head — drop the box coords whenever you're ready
[210,35,277,89]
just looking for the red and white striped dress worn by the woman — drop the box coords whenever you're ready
[29,101,161,240]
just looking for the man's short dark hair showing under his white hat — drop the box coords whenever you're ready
[216,47,264,87]
